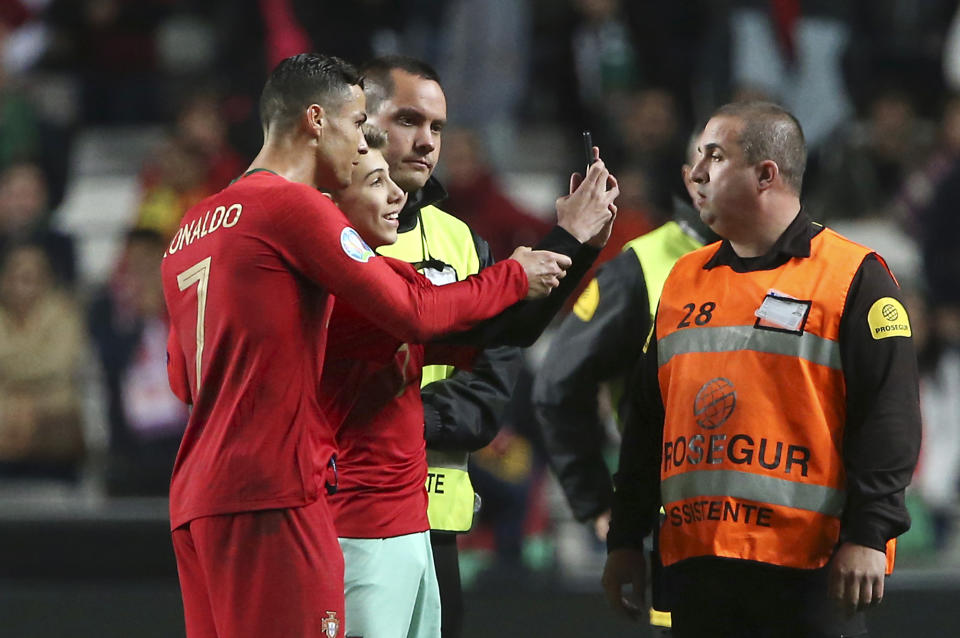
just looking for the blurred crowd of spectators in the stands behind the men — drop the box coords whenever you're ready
[0,0,960,584]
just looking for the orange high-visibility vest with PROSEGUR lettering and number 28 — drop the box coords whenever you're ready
[656,229,892,569]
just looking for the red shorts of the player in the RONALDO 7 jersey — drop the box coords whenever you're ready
[173,498,343,638]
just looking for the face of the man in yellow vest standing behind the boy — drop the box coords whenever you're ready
[370,69,447,193]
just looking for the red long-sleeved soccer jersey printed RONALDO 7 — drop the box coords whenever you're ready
[161,171,527,529]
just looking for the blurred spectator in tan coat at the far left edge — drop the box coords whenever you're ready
[0,243,85,481]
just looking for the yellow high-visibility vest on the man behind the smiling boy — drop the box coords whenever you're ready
[378,206,480,532]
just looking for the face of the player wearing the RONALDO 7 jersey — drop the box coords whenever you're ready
[316,86,367,191]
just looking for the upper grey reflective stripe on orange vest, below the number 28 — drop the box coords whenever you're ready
[657,326,842,370]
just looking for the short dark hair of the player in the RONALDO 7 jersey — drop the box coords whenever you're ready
[260,53,363,130]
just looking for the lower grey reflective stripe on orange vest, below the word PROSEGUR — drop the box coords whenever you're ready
[660,470,846,516]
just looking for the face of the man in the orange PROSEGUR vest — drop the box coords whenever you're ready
[690,116,759,238]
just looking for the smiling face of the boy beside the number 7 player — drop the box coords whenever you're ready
[332,150,407,248]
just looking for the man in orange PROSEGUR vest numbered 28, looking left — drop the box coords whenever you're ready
[603,102,920,638]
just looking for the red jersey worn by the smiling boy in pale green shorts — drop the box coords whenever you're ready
[321,296,476,538]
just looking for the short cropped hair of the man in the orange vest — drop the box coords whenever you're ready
[711,101,807,195]
